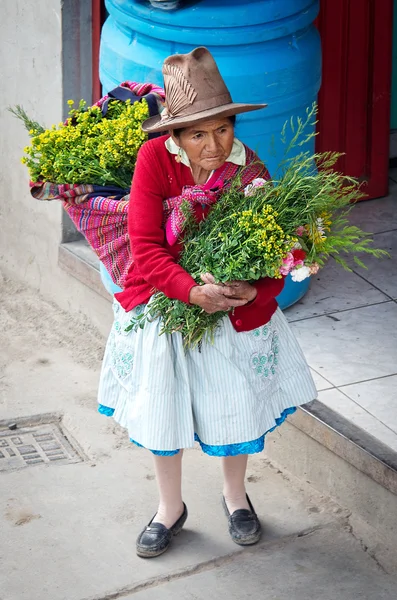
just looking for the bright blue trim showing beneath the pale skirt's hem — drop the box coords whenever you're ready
[98,404,296,456]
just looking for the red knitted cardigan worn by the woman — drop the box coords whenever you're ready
[115,136,284,331]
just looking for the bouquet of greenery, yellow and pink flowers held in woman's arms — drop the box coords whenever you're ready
[128,106,387,347]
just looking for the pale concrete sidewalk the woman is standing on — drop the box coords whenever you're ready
[0,281,397,600]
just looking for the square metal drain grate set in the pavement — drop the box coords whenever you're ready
[0,423,82,471]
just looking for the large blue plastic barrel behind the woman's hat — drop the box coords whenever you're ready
[100,0,321,304]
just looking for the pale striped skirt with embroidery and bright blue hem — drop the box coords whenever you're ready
[98,300,317,456]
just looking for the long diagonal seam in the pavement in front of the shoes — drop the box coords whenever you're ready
[84,525,324,600]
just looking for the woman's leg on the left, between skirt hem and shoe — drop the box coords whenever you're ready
[153,450,183,529]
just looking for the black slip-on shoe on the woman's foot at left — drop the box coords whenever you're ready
[136,503,187,558]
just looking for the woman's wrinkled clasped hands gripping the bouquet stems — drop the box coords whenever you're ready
[189,277,249,314]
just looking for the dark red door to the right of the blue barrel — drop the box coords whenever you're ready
[316,0,393,198]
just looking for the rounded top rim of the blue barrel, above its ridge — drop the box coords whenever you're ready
[106,0,319,45]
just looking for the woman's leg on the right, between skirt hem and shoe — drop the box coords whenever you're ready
[222,454,250,514]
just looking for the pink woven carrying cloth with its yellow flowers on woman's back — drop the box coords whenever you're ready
[9,81,164,286]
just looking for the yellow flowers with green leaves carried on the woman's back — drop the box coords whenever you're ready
[13,99,149,189]
